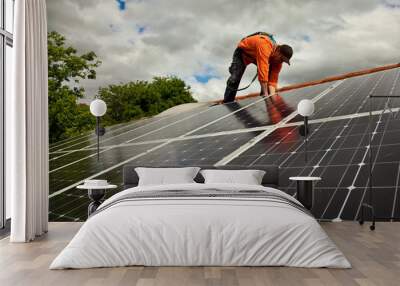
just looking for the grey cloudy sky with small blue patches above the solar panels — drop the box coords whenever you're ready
[47,0,400,101]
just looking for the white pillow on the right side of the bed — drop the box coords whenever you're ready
[200,170,265,185]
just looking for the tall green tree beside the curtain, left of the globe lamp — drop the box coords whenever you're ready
[47,32,101,142]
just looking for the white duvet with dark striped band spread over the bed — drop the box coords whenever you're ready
[50,184,351,269]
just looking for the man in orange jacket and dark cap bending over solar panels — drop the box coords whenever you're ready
[223,32,293,103]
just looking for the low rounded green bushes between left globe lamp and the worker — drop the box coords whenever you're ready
[99,77,195,125]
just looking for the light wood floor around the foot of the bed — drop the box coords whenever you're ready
[0,222,400,286]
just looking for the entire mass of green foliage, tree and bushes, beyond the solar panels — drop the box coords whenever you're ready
[48,32,195,143]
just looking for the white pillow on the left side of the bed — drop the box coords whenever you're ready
[135,167,200,186]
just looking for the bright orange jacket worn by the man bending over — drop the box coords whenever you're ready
[238,35,282,88]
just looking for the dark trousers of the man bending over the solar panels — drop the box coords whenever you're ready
[223,48,246,103]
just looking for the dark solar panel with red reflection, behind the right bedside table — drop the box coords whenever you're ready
[231,116,400,219]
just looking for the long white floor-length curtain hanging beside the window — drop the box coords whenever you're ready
[6,0,49,242]
